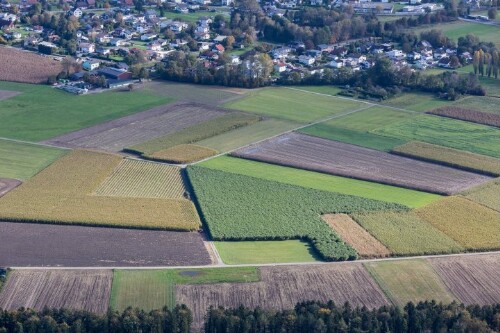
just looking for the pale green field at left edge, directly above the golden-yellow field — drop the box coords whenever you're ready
[0,139,67,180]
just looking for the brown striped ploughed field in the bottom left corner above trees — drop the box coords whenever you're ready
[0,270,113,314]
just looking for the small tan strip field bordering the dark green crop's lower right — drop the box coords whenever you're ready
[322,214,391,258]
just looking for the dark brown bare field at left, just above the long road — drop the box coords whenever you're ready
[0,222,211,267]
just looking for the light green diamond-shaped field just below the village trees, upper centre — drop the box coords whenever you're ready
[225,88,363,123]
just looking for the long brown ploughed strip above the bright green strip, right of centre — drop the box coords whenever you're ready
[233,133,491,194]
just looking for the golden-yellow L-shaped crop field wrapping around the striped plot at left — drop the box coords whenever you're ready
[0,151,200,230]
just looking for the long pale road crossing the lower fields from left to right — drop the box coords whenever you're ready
[9,251,500,270]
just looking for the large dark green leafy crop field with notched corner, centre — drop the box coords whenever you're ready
[188,167,404,260]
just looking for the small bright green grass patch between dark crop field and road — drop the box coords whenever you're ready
[215,240,319,265]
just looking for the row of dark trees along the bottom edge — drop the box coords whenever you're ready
[0,301,500,333]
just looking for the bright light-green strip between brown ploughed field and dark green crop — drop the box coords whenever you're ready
[200,156,440,208]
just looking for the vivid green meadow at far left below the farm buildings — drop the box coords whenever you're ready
[0,82,173,141]
